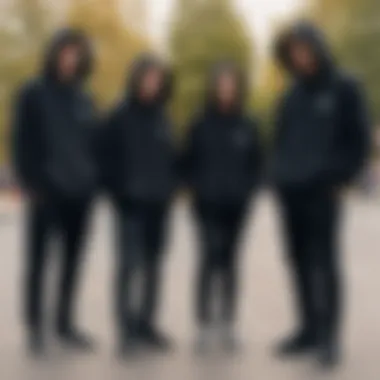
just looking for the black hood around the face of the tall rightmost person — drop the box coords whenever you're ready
[275,21,334,75]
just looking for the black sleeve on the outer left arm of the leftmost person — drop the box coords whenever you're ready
[11,85,42,192]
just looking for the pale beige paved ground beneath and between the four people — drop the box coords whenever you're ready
[0,197,380,380]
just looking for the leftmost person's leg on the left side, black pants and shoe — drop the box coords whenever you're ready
[24,200,52,352]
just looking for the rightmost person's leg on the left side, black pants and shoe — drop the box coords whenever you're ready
[279,192,316,355]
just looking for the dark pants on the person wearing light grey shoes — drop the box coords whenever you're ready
[195,203,245,326]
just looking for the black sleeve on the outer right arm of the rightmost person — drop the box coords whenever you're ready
[335,81,371,183]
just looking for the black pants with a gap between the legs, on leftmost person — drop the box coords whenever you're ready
[25,196,90,332]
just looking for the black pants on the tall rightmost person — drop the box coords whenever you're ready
[280,189,341,340]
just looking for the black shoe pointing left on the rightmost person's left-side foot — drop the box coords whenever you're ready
[277,332,318,358]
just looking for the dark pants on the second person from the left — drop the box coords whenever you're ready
[115,200,168,333]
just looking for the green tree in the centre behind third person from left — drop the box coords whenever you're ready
[169,0,253,134]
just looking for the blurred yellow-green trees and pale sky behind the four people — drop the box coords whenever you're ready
[0,0,380,191]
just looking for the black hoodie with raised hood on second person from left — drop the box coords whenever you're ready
[101,55,177,202]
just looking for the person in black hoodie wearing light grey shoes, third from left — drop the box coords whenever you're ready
[183,62,261,350]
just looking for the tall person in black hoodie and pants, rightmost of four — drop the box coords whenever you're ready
[273,22,370,366]
